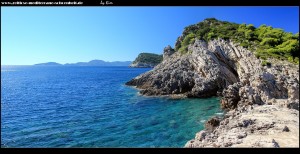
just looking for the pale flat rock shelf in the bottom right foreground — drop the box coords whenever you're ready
[184,104,299,148]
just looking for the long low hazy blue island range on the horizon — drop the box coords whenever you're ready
[35,60,131,66]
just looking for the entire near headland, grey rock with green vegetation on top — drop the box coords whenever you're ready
[126,19,299,148]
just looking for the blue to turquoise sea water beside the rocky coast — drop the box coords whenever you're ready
[1,66,222,148]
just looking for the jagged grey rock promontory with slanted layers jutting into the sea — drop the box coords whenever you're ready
[126,40,252,97]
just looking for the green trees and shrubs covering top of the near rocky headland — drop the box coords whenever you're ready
[175,18,299,64]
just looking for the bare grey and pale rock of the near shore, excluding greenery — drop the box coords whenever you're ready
[126,39,299,147]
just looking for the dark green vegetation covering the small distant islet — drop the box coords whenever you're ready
[133,53,163,65]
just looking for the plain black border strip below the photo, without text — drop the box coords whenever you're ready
[1,148,299,154]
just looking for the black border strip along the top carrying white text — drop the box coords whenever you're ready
[1,0,299,7]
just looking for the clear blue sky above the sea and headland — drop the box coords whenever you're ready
[1,6,299,65]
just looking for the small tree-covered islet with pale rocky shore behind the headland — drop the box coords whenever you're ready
[130,53,163,68]
